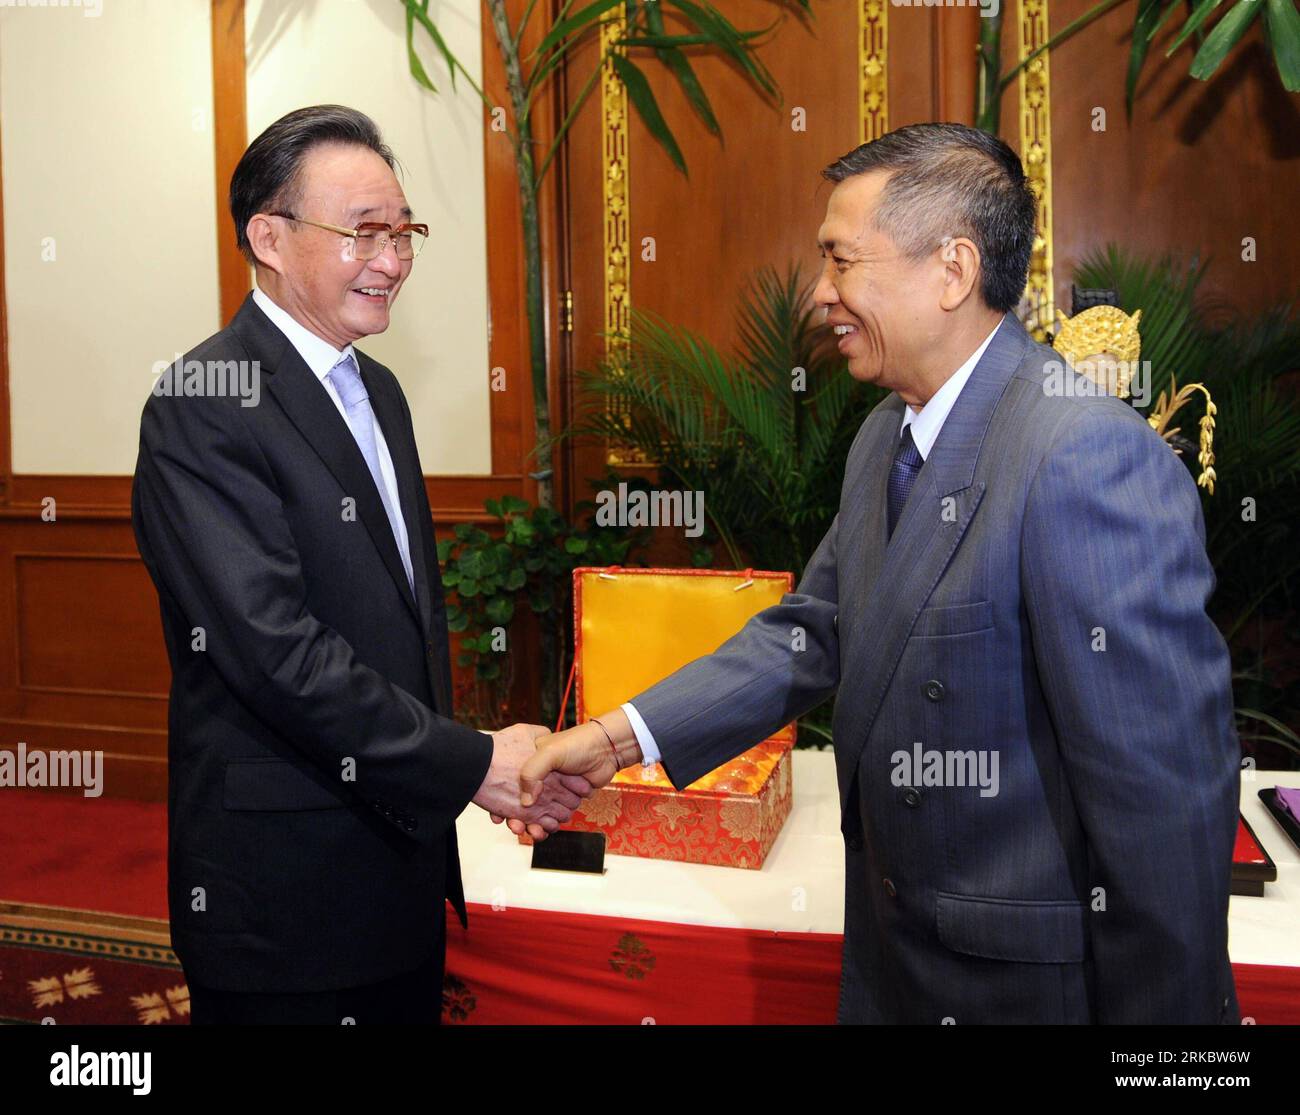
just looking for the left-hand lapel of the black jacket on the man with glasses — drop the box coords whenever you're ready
[231,295,420,622]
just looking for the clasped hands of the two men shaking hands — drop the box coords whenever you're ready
[473,708,641,839]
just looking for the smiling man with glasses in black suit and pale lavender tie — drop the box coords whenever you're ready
[133,105,590,1024]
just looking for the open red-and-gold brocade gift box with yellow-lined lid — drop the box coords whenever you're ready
[548,567,796,868]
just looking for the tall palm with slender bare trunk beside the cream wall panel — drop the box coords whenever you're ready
[399,0,811,507]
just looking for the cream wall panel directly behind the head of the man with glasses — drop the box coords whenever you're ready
[244,0,491,473]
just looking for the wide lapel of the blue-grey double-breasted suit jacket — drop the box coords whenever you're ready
[835,314,1030,816]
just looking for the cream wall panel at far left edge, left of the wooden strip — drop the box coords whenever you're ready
[0,0,220,474]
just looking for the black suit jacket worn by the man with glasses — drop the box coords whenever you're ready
[131,296,491,992]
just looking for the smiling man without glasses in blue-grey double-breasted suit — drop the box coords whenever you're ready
[524,123,1240,1024]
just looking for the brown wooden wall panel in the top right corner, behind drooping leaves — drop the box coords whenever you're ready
[1045,0,1300,309]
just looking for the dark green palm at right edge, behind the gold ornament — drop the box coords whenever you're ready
[1074,244,1300,754]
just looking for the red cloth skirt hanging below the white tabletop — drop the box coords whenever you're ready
[443,903,1300,1025]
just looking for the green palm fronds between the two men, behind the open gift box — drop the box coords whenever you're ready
[567,268,883,574]
